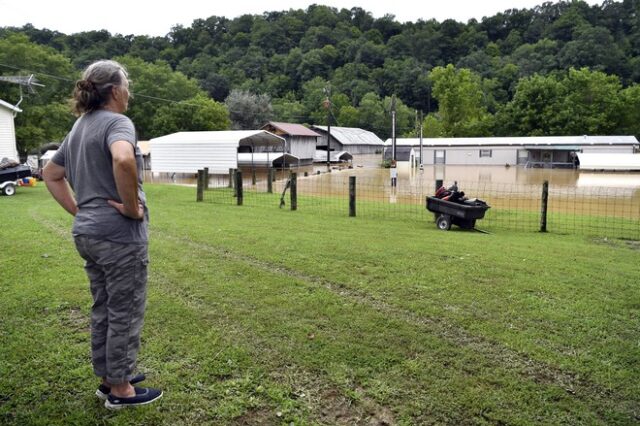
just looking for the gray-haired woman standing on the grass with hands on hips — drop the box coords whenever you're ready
[43,60,162,409]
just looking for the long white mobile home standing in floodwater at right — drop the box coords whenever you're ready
[384,136,639,167]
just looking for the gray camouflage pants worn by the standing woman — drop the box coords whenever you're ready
[75,235,149,384]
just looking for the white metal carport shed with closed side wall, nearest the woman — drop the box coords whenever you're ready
[149,130,284,174]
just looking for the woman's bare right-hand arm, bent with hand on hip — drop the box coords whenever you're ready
[109,141,144,219]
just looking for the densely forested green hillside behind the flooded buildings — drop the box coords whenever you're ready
[0,0,640,153]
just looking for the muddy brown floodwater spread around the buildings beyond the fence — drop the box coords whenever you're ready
[145,155,640,219]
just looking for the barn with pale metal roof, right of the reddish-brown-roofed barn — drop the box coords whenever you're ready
[311,126,384,154]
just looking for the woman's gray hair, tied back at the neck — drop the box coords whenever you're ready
[73,60,128,115]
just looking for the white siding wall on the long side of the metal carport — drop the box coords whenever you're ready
[151,140,238,174]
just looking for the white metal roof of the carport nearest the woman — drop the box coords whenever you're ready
[151,130,284,146]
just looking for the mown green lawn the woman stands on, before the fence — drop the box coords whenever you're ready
[0,185,640,425]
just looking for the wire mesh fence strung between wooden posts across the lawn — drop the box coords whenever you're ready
[202,172,640,240]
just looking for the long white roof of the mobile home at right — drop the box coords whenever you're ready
[384,136,638,147]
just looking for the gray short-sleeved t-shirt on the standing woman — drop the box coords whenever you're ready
[51,110,149,243]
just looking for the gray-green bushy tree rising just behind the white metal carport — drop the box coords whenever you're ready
[224,89,273,130]
